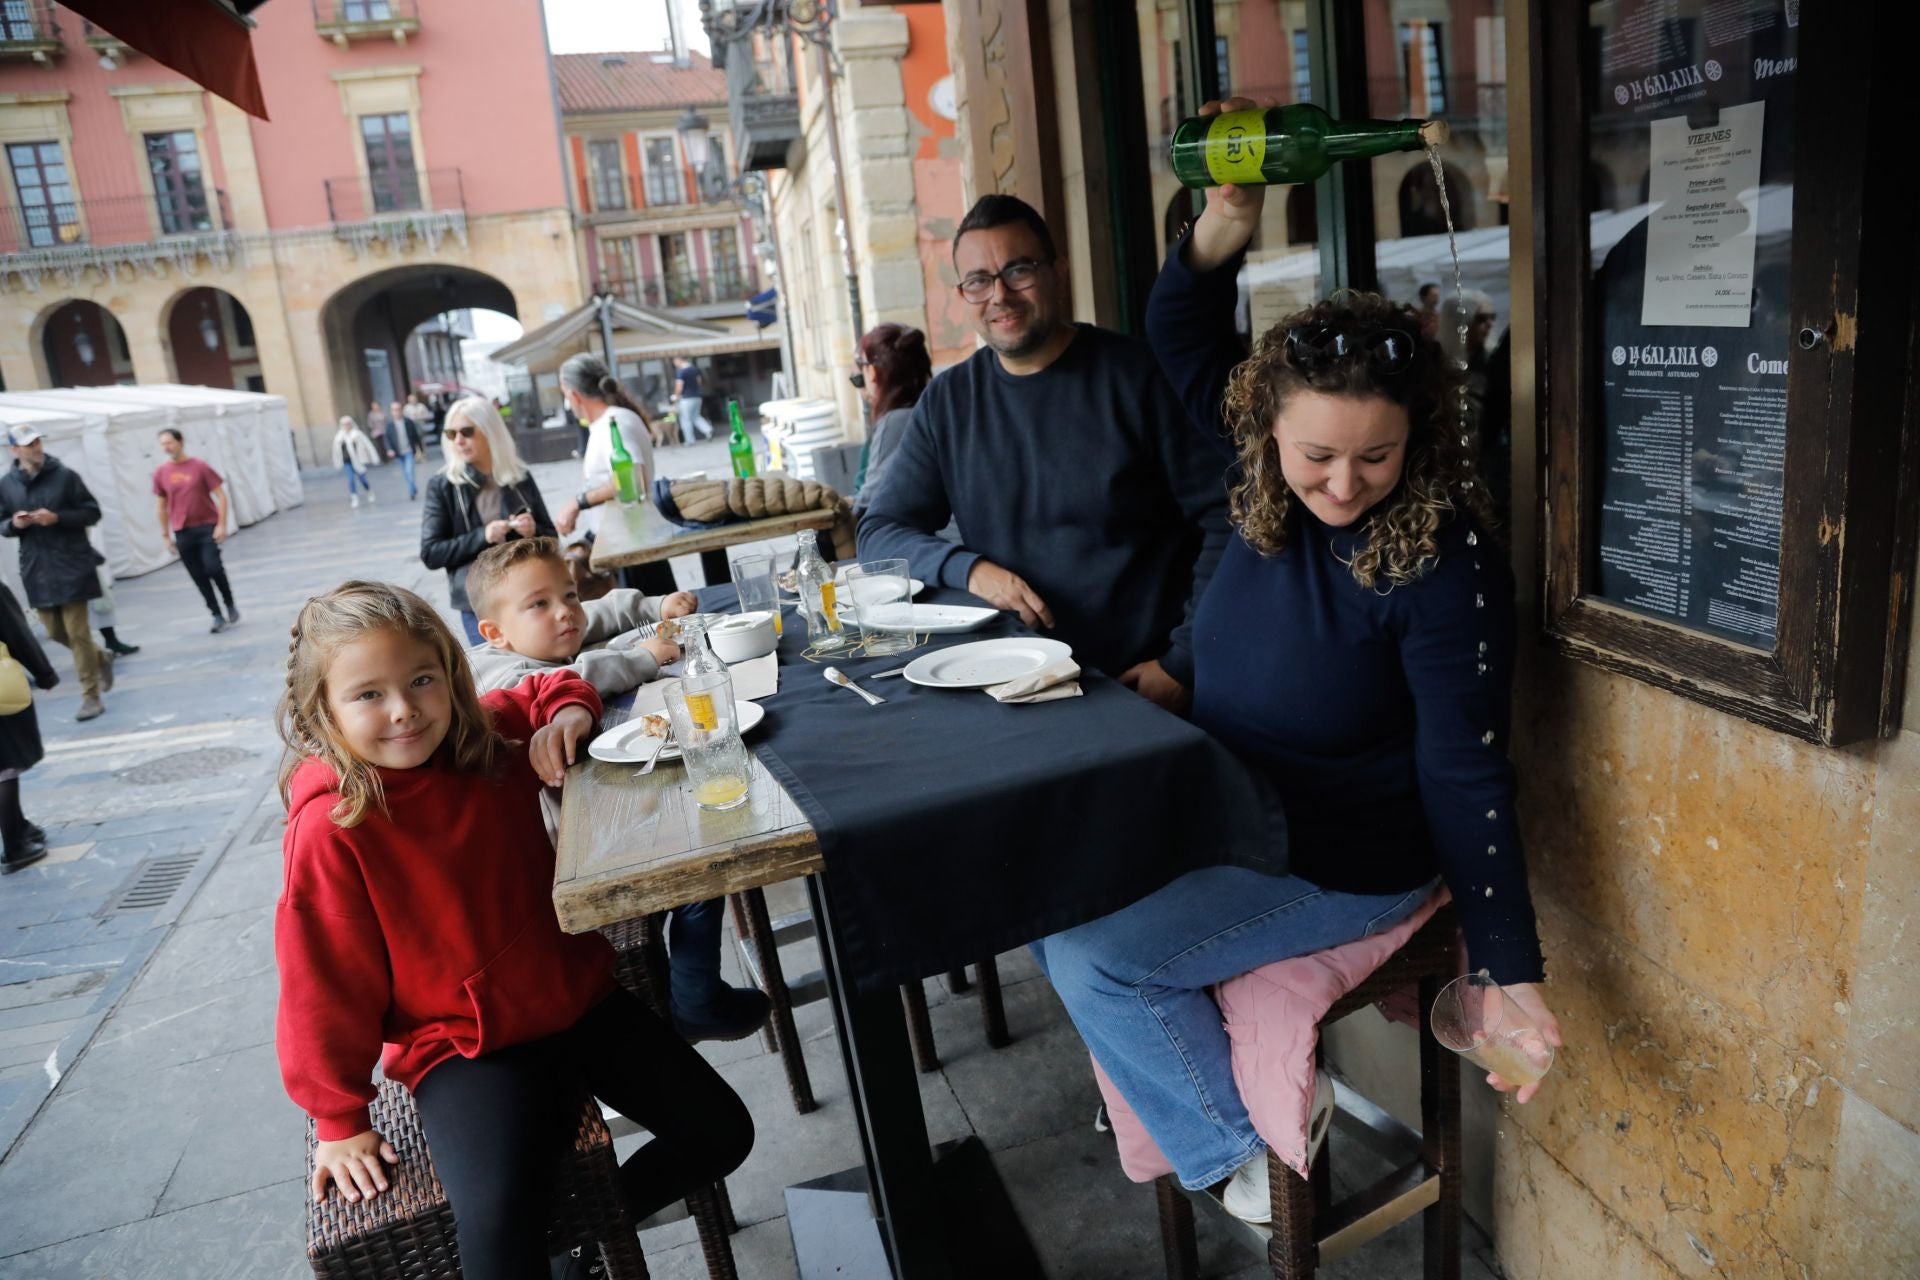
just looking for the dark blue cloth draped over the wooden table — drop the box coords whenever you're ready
[701,585,1286,990]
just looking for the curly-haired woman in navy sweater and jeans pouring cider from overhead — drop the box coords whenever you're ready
[1039,100,1559,1221]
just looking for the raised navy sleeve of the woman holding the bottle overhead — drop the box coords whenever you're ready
[1146,230,1246,461]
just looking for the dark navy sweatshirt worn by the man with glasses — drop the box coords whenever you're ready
[858,324,1227,687]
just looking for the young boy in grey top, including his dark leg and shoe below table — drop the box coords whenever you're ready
[467,537,770,1040]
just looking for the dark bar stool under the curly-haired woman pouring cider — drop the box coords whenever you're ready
[1154,906,1461,1280]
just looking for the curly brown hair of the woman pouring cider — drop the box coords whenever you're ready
[1223,290,1494,589]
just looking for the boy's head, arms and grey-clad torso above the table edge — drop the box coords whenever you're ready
[467,537,695,699]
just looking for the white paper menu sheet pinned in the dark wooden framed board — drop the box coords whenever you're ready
[1640,102,1766,328]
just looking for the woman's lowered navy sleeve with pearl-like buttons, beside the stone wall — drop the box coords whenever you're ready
[1392,520,1544,983]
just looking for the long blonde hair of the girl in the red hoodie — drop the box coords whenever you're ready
[275,581,505,827]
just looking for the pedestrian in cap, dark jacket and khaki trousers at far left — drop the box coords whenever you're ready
[0,424,113,720]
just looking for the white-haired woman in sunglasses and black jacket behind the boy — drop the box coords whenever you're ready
[420,395,555,645]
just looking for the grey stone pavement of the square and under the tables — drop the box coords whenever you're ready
[0,435,1490,1280]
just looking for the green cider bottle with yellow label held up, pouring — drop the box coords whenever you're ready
[1169,102,1448,186]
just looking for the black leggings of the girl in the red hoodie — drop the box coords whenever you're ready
[413,990,753,1280]
